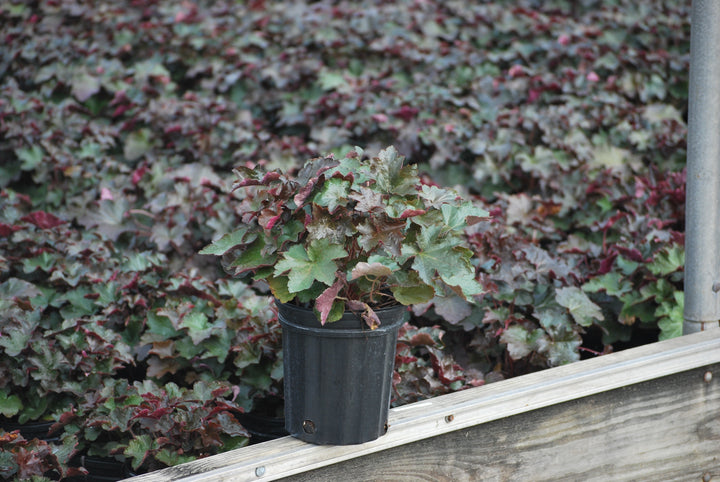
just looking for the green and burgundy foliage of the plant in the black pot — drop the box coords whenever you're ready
[202,146,488,328]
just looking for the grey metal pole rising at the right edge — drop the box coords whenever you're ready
[683,0,720,334]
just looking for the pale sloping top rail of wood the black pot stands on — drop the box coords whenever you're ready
[126,330,720,482]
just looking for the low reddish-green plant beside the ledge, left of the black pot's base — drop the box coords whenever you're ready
[51,380,249,471]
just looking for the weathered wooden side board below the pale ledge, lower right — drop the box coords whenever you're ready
[284,365,720,482]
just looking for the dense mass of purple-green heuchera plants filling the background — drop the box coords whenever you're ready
[0,0,690,478]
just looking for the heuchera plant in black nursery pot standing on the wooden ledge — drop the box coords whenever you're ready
[201,146,487,444]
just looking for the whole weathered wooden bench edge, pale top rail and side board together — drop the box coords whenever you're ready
[126,330,720,482]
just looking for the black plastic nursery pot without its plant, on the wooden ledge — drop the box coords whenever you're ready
[278,303,406,445]
